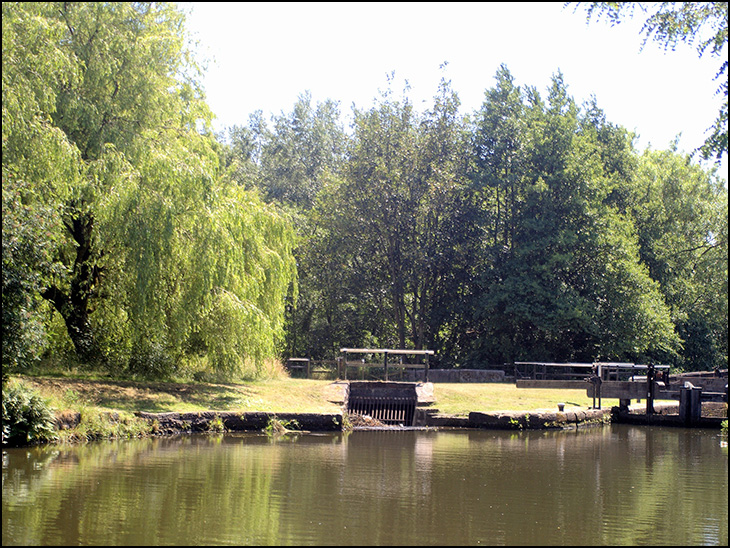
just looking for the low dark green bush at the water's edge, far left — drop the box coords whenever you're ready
[2,383,55,446]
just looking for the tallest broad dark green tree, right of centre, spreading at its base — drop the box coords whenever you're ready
[472,68,676,363]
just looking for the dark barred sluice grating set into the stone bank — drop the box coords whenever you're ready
[347,381,418,426]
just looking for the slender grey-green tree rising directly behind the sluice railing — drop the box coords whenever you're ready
[341,88,416,348]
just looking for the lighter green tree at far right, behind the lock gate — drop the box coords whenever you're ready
[631,150,728,370]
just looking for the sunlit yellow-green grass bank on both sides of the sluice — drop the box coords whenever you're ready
[14,376,618,441]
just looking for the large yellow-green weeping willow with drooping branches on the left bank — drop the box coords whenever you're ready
[3,2,294,375]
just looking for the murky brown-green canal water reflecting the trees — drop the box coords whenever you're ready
[2,425,728,546]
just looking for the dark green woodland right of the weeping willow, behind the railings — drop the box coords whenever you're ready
[232,66,727,369]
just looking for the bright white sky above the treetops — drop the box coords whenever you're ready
[179,2,727,173]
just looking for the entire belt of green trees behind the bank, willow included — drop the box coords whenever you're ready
[2,2,728,379]
